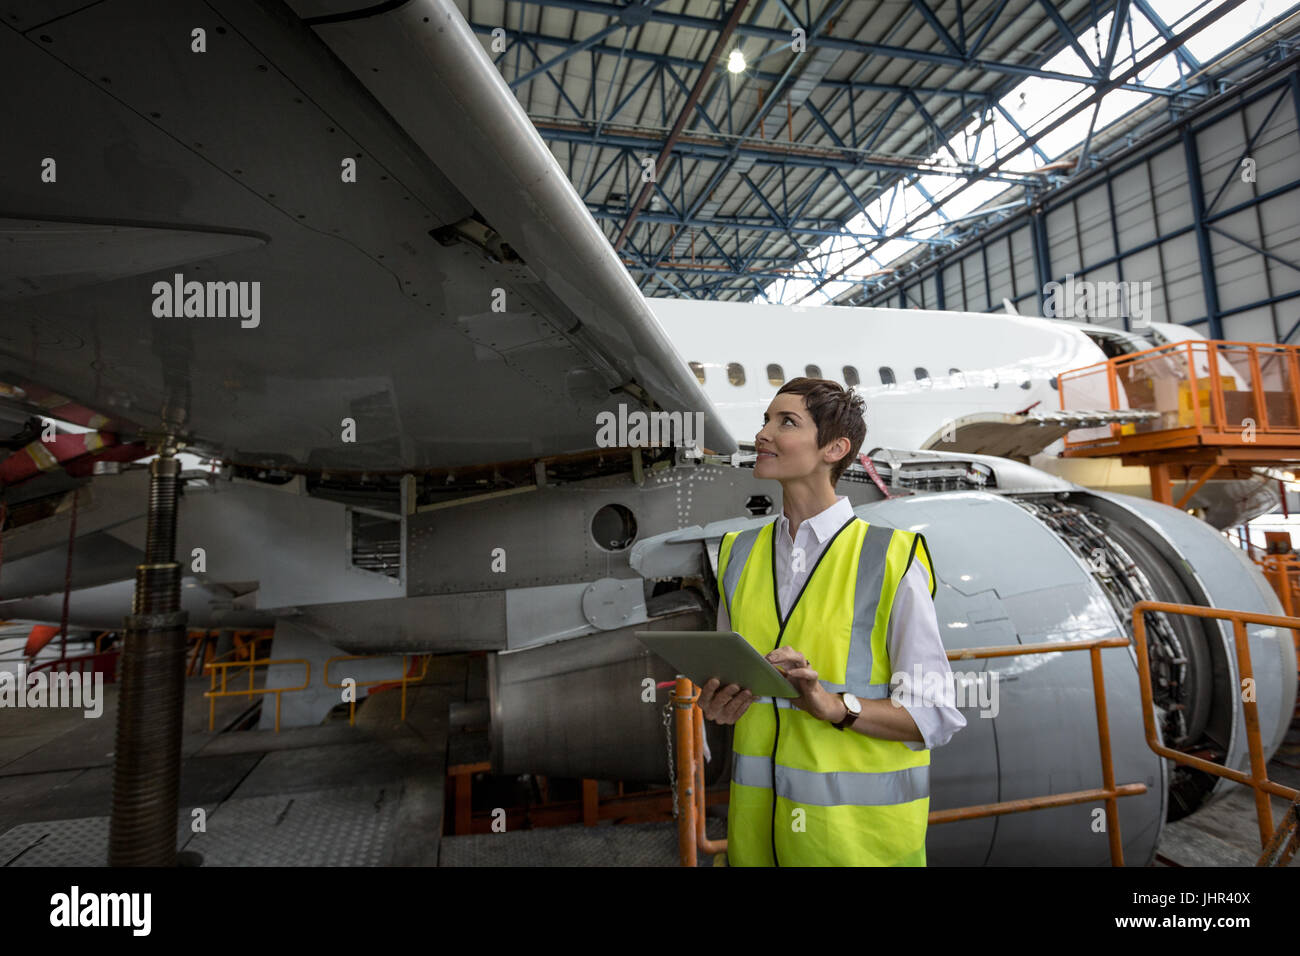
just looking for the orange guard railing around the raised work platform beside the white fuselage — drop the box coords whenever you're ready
[1058,339,1300,450]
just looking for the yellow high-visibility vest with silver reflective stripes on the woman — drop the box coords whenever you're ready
[718,516,935,866]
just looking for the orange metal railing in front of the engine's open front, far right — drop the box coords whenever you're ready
[1134,601,1300,865]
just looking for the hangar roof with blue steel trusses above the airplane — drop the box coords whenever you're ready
[459,0,1289,300]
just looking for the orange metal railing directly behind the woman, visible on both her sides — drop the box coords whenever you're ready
[672,637,1147,866]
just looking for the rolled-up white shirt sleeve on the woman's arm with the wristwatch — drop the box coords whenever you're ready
[887,561,966,750]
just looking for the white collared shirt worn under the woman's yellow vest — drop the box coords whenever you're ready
[718,494,966,750]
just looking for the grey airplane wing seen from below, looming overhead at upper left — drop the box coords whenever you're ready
[0,0,736,472]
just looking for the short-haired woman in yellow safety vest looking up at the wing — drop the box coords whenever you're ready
[699,378,966,866]
